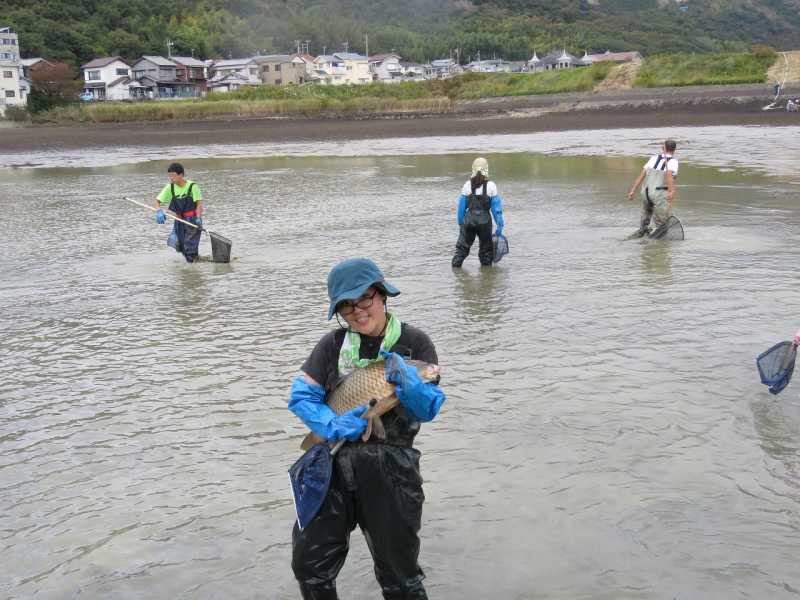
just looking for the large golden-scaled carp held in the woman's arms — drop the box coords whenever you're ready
[300,360,441,450]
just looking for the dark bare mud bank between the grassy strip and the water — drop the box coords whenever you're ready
[0,84,800,154]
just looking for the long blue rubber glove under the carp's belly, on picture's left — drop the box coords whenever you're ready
[289,376,369,442]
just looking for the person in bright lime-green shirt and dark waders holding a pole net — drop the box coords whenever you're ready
[156,163,203,262]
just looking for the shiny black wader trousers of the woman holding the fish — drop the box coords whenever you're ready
[292,443,428,600]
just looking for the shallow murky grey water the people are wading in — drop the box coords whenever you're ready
[0,127,800,600]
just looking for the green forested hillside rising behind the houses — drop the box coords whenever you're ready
[0,0,800,64]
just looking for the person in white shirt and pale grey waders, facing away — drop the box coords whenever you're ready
[628,140,678,237]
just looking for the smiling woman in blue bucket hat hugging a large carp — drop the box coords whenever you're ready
[289,258,445,600]
